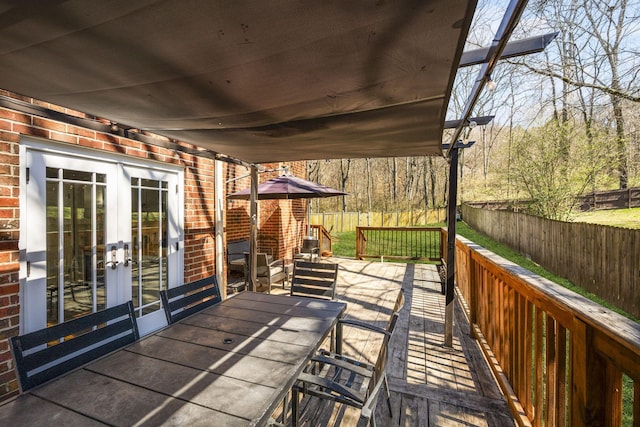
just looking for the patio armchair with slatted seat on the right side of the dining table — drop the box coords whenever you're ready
[291,291,404,426]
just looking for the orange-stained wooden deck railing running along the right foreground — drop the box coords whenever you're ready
[448,237,640,426]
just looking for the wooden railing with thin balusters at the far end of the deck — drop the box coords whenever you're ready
[356,227,444,262]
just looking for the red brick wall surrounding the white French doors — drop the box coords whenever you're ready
[0,91,215,401]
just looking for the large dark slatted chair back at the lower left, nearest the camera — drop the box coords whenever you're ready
[11,301,140,391]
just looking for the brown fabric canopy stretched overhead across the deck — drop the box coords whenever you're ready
[0,0,476,163]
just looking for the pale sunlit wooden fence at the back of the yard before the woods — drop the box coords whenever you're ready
[311,209,446,233]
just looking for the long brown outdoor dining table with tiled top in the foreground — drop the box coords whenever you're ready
[0,292,346,426]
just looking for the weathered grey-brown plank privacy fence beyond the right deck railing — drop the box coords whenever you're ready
[462,205,640,317]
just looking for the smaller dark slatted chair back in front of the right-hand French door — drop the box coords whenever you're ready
[160,275,222,324]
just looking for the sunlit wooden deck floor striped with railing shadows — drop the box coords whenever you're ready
[273,258,515,426]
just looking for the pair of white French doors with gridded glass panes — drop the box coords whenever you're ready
[21,143,183,334]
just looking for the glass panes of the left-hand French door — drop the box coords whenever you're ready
[46,168,106,326]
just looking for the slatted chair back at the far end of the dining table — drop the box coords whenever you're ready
[290,260,338,299]
